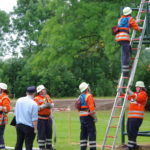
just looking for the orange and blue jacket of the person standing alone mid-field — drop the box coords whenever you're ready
[79,92,96,116]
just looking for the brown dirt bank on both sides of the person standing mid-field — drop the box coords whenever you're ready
[54,99,114,110]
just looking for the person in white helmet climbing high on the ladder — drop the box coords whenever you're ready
[115,7,141,77]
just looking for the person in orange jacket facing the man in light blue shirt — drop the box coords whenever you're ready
[34,85,54,150]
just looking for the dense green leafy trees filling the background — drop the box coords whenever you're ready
[0,0,150,110]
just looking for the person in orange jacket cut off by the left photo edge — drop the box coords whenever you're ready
[0,83,10,150]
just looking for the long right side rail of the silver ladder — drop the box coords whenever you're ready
[112,17,146,150]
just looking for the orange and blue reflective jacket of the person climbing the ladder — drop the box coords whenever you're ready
[115,16,140,42]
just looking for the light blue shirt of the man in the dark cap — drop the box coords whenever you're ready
[15,95,38,127]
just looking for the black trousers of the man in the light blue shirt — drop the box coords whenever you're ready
[15,124,35,150]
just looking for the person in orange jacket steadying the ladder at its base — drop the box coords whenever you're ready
[126,81,148,150]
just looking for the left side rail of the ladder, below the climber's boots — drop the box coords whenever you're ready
[101,74,124,150]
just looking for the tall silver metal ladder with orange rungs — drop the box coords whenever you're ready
[101,0,150,150]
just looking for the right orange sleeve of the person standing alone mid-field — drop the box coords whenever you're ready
[87,94,96,114]
